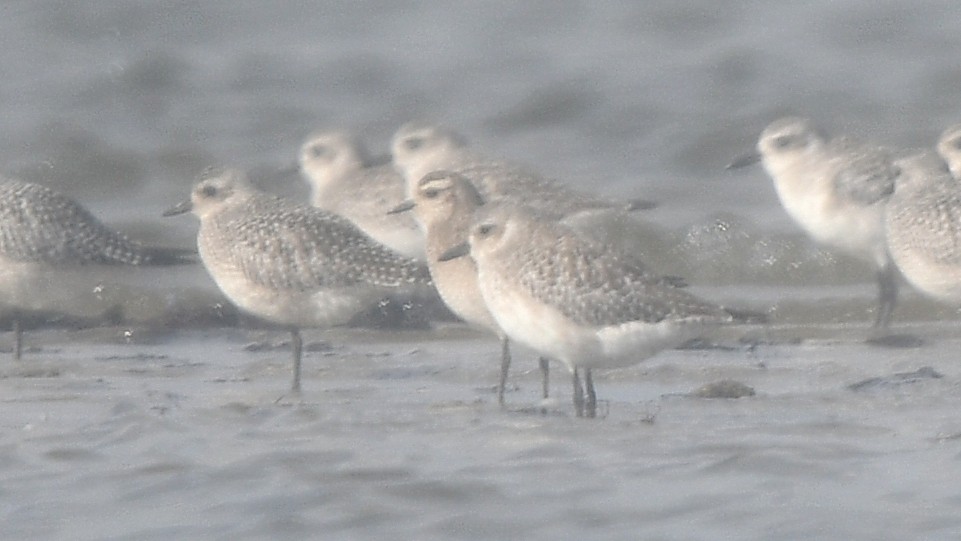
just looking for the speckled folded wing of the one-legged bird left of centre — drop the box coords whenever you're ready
[224,196,430,291]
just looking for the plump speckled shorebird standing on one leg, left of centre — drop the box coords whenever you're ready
[164,169,430,392]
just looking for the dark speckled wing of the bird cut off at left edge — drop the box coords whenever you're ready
[0,180,150,265]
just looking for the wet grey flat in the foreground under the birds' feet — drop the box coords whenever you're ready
[0,322,961,539]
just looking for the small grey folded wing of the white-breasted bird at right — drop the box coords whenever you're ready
[831,138,899,205]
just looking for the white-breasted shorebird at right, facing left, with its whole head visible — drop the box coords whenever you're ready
[728,117,898,328]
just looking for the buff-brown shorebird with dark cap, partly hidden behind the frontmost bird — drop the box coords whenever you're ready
[391,171,549,406]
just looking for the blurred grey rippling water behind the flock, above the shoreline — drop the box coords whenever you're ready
[0,0,961,295]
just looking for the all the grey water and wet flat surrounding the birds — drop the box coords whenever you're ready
[0,0,961,540]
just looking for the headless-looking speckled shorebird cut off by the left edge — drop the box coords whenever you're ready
[0,178,195,359]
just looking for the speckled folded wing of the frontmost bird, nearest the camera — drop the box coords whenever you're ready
[519,229,730,326]
